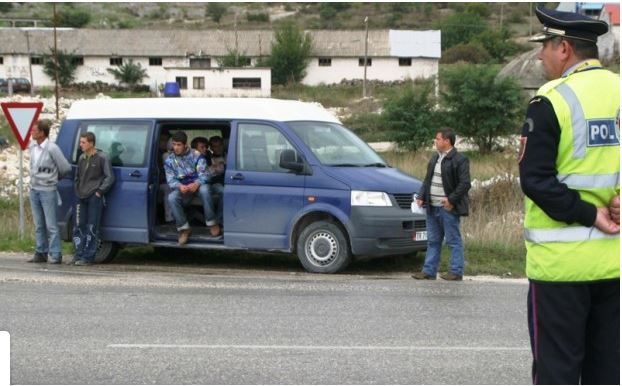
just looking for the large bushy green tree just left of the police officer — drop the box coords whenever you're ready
[441,65,523,154]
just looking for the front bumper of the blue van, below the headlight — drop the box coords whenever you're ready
[348,206,427,258]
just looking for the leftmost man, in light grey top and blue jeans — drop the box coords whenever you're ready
[28,119,71,264]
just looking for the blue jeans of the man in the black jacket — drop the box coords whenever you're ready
[423,206,464,276]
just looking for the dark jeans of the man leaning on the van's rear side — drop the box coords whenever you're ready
[73,194,104,262]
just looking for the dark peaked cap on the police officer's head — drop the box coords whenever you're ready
[529,7,609,43]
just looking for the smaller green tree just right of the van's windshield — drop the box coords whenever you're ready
[382,82,439,150]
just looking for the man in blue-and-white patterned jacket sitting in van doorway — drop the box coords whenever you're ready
[164,131,220,245]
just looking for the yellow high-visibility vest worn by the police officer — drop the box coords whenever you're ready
[524,60,620,282]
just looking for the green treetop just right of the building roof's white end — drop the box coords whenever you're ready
[436,12,488,50]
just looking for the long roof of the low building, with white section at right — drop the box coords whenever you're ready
[0,28,441,58]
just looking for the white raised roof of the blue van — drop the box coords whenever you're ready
[67,98,340,123]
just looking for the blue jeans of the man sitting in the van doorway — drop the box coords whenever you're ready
[168,184,222,231]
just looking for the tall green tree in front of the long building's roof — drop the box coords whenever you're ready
[266,23,312,84]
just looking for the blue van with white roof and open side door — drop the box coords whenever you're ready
[57,98,426,273]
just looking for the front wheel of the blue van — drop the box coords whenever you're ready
[296,221,352,273]
